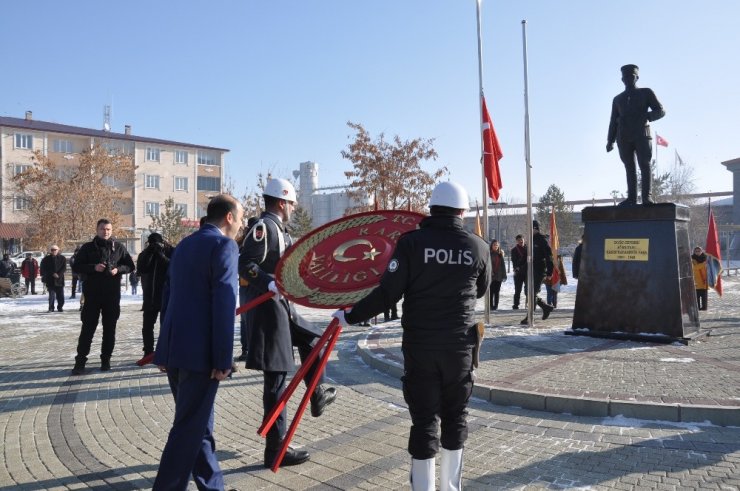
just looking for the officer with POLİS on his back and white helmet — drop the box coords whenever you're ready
[333,182,491,490]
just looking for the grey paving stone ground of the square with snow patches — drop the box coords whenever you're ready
[0,277,740,491]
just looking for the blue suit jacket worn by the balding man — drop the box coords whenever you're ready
[154,224,239,372]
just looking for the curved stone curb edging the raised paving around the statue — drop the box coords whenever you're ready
[357,334,740,426]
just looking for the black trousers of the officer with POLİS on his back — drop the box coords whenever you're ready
[401,346,473,460]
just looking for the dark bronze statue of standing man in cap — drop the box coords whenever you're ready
[606,65,665,206]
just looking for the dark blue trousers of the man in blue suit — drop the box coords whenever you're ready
[153,368,224,491]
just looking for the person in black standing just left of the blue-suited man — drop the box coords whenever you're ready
[136,232,174,366]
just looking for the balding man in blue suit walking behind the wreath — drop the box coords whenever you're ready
[154,194,244,490]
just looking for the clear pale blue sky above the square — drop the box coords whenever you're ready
[0,0,740,203]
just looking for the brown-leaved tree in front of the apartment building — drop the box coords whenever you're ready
[13,143,136,247]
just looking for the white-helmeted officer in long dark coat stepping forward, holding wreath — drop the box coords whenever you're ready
[239,179,336,467]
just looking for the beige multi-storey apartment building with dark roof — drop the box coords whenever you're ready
[0,111,228,250]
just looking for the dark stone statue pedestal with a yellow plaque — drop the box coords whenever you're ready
[566,203,699,342]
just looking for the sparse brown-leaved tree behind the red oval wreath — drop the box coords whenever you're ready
[342,121,448,212]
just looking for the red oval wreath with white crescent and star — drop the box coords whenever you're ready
[275,210,424,308]
